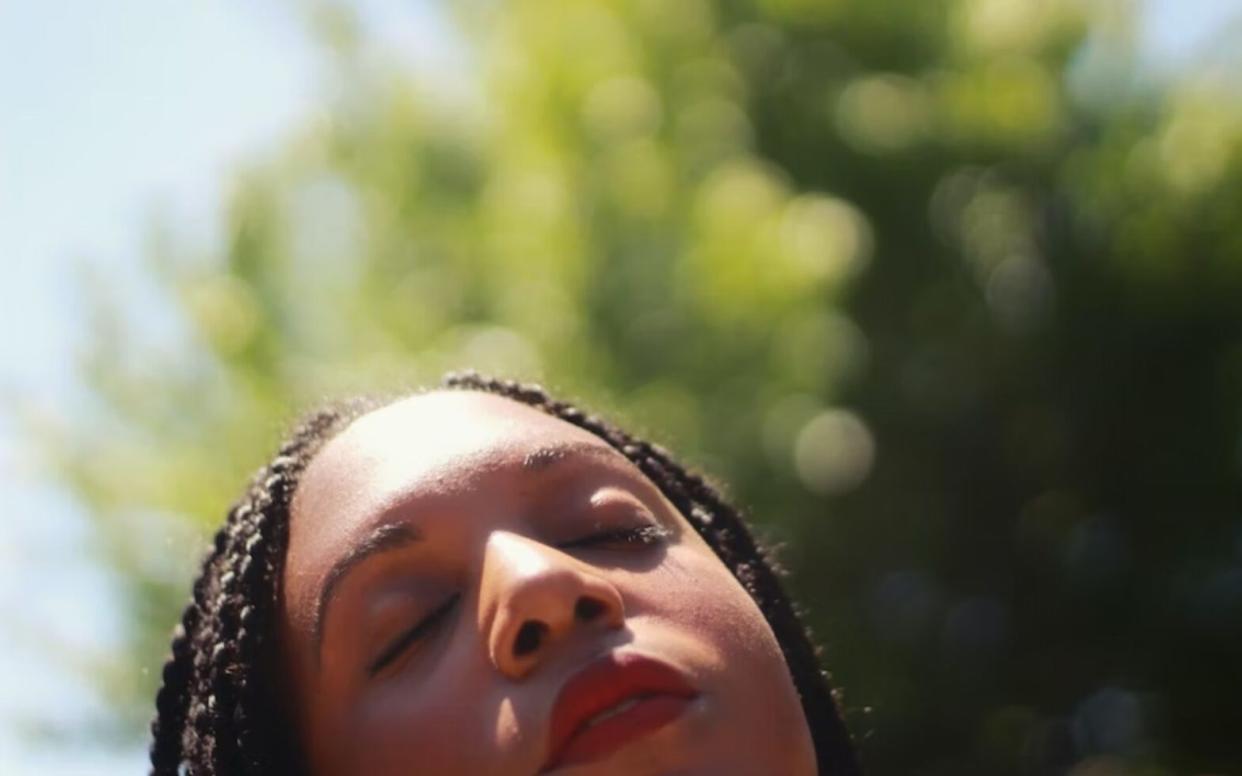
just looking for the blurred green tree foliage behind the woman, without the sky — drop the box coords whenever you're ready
[38,0,1242,776]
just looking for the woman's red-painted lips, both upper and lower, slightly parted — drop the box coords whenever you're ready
[539,652,699,774]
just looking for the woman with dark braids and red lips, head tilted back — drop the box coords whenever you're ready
[152,374,858,776]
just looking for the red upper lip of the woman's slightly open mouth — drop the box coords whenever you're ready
[542,652,699,771]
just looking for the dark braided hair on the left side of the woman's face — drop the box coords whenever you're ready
[150,399,376,776]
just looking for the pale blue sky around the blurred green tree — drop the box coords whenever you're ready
[0,0,1242,776]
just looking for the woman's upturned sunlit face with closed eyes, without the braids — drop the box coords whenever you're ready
[279,391,815,776]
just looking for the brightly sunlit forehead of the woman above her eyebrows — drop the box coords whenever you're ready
[291,391,621,550]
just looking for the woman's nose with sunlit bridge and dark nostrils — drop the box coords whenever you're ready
[481,531,625,679]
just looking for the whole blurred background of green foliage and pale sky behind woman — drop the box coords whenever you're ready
[0,0,1242,776]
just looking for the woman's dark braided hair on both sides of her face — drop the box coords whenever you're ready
[150,372,859,776]
